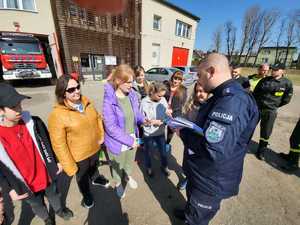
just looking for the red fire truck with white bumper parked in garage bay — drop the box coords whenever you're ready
[0,33,52,80]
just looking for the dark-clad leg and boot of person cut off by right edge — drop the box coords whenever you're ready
[279,118,300,172]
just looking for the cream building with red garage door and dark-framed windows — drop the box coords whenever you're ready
[141,0,200,69]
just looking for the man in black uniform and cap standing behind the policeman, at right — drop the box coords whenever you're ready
[253,63,293,160]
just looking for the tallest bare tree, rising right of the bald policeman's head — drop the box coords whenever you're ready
[238,6,260,62]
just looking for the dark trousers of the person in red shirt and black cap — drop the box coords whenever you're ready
[25,182,63,220]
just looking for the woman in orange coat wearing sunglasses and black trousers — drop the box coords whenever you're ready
[48,75,109,208]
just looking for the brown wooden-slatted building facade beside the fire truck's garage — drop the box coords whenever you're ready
[52,0,141,79]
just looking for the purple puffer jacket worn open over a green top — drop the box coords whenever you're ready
[102,83,145,155]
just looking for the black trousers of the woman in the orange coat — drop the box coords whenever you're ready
[76,152,99,198]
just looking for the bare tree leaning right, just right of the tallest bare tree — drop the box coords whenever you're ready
[253,9,279,65]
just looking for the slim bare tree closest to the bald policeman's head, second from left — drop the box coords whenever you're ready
[224,21,236,62]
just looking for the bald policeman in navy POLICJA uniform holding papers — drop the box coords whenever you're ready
[175,53,259,225]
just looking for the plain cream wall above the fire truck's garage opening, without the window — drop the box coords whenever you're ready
[0,0,55,35]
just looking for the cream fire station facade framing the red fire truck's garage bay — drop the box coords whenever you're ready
[0,0,60,77]
